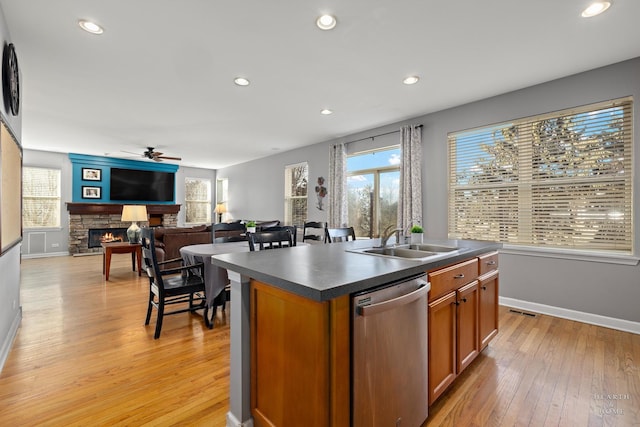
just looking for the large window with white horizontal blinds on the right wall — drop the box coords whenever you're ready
[449,98,633,253]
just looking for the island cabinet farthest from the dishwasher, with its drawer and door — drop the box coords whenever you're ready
[478,252,499,351]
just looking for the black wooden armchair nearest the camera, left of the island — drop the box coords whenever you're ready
[142,227,213,339]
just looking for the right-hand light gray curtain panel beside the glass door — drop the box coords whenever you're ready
[398,126,426,233]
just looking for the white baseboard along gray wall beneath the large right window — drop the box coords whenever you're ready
[499,297,640,335]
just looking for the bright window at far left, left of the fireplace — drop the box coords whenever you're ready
[22,167,60,228]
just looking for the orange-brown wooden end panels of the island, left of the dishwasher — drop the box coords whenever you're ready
[250,280,351,427]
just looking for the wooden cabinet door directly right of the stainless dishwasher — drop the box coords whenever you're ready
[428,292,456,405]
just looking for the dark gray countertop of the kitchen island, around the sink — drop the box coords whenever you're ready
[212,239,502,301]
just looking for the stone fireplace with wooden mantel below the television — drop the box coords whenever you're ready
[67,203,180,255]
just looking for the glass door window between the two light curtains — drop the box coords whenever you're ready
[347,146,401,237]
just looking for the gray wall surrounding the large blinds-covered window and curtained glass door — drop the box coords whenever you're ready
[218,58,640,327]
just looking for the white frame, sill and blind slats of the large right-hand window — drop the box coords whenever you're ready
[447,97,638,263]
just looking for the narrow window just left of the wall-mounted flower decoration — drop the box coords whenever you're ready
[284,162,309,227]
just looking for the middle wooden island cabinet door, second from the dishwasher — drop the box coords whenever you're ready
[457,280,480,374]
